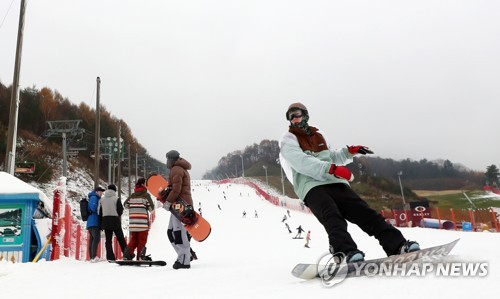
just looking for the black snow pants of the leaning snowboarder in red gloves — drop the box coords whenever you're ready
[304,183,406,256]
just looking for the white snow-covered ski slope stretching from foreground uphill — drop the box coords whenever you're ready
[0,181,500,299]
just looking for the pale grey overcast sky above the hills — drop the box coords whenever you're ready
[0,0,500,178]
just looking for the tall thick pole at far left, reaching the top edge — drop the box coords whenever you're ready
[5,0,26,175]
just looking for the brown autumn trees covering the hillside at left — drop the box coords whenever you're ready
[0,82,162,179]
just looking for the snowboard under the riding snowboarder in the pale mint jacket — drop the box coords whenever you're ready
[292,239,460,281]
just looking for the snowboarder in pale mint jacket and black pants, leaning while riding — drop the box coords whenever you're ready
[279,103,420,262]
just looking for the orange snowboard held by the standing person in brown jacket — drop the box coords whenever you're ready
[146,174,212,242]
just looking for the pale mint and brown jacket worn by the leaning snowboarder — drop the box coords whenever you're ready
[279,126,353,200]
